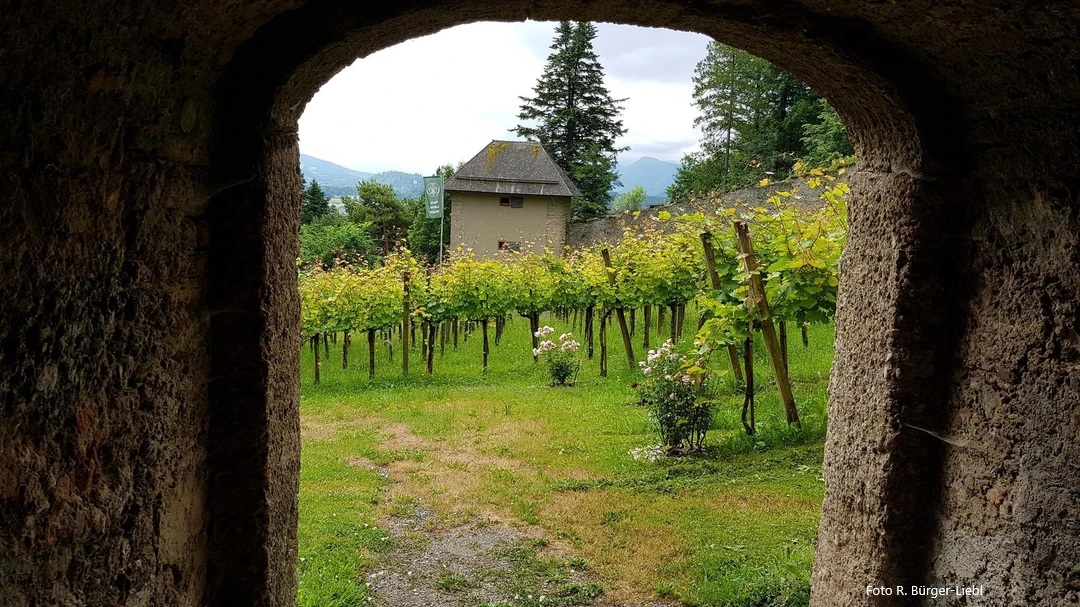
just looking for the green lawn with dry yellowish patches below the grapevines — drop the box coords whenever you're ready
[299,314,833,606]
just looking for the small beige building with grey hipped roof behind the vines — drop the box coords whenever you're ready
[445,141,581,257]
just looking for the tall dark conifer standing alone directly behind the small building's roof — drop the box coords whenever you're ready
[511,22,626,220]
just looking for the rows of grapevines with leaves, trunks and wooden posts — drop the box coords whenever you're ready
[299,167,848,433]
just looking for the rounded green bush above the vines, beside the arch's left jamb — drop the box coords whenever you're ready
[300,213,379,270]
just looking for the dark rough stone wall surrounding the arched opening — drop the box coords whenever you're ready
[0,0,1080,607]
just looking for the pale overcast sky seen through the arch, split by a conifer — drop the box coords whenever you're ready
[300,22,708,175]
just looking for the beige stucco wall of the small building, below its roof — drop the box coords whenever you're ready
[450,192,570,257]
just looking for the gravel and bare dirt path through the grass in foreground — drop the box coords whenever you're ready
[358,424,673,607]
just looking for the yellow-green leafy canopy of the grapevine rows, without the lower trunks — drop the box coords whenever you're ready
[300,163,848,382]
